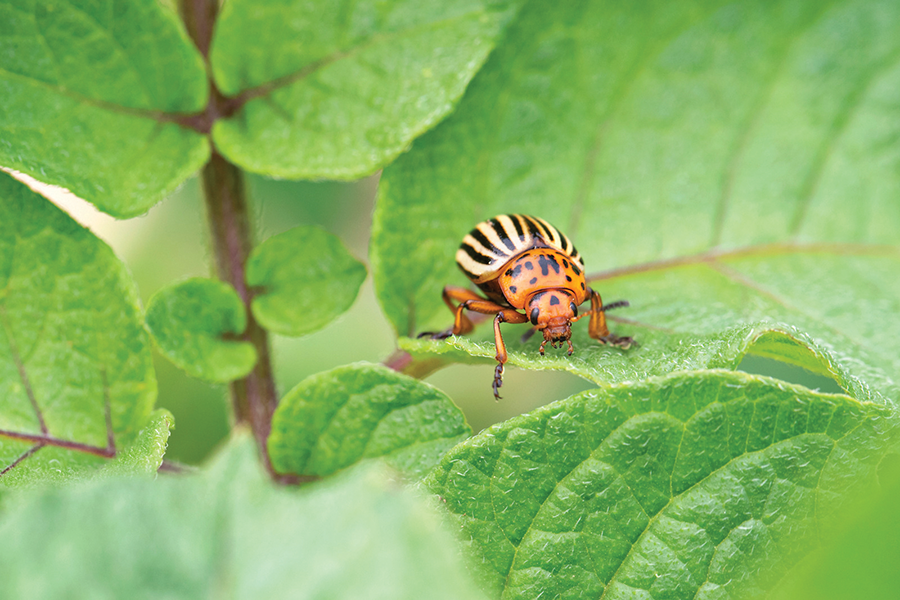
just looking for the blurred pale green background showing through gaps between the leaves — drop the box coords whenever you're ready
[54,175,840,464]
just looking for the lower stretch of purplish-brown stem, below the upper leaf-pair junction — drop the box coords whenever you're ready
[203,152,278,464]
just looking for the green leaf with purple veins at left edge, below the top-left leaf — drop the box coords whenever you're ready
[0,173,156,487]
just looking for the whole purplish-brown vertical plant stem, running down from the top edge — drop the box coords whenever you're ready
[179,0,278,473]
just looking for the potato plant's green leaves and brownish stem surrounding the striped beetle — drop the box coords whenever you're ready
[0,0,900,600]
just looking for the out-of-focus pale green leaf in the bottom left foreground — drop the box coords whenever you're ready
[0,442,492,600]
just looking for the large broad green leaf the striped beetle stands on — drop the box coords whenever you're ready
[372,0,900,399]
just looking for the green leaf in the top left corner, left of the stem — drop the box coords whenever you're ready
[0,0,209,217]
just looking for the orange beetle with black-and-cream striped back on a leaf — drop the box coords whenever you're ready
[419,215,634,400]
